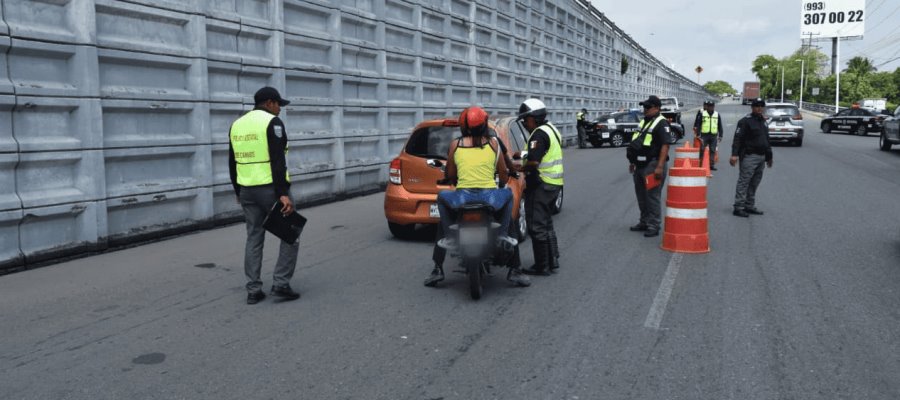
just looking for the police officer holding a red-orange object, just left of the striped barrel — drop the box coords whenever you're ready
[626,96,672,237]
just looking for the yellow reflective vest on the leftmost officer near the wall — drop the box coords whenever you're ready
[229,110,291,186]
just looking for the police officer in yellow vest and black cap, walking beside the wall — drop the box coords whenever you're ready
[228,87,300,304]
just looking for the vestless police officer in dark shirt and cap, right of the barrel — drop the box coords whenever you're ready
[728,99,772,218]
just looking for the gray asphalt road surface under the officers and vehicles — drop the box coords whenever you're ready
[0,105,900,399]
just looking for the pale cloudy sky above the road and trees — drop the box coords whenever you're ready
[591,0,900,91]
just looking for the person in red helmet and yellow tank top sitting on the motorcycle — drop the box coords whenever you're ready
[425,107,531,286]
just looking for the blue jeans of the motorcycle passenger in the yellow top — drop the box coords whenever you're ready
[438,188,512,235]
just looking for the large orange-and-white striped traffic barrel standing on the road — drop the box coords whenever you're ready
[661,163,709,253]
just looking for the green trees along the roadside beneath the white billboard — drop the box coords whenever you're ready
[751,48,900,104]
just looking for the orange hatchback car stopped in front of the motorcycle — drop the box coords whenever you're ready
[384,117,528,241]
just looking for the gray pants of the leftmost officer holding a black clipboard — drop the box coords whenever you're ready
[240,185,300,293]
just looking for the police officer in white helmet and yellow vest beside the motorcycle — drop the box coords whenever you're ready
[519,99,563,275]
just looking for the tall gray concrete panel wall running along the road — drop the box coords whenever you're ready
[0,0,705,270]
